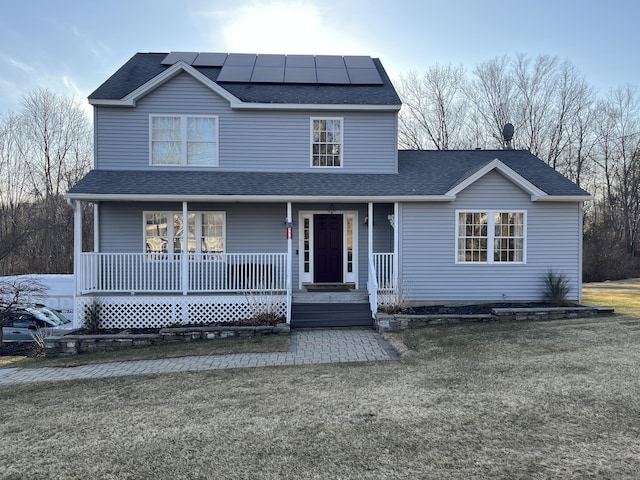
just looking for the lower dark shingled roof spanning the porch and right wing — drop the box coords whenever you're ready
[67,150,590,201]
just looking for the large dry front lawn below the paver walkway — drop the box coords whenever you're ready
[0,284,640,480]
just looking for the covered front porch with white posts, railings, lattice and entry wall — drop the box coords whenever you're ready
[74,202,397,328]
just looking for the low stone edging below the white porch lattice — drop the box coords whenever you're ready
[44,323,290,357]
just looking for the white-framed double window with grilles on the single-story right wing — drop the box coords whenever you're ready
[456,211,526,263]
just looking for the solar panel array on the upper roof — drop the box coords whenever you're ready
[162,52,383,85]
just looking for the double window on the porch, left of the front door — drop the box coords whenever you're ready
[144,212,225,253]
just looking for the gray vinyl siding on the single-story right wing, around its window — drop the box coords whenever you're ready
[400,172,582,302]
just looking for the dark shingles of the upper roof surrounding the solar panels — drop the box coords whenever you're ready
[89,53,401,107]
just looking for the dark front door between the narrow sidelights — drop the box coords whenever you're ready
[313,214,343,283]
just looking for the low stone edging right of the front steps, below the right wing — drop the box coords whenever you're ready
[375,305,613,332]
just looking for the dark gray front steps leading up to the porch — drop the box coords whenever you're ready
[291,302,373,328]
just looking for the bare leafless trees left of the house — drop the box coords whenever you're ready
[0,89,93,275]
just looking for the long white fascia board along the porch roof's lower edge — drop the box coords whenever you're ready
[66,193,456,203]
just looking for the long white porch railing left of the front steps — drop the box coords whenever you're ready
[78,253,287,293]
